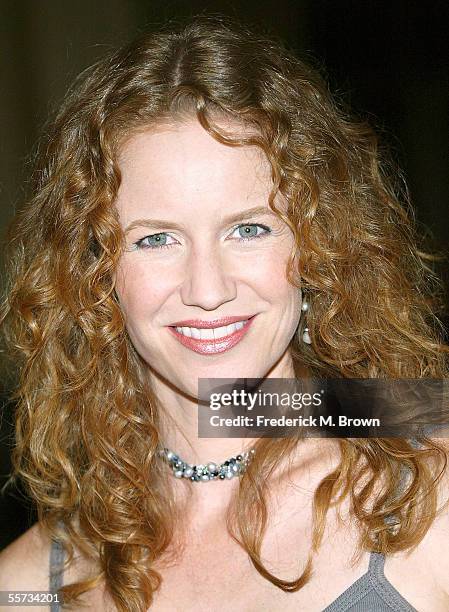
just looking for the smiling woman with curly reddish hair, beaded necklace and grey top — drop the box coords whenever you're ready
[0,18,449,612]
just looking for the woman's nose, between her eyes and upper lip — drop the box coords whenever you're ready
[181,245,237,310]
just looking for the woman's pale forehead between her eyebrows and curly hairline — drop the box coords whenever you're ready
[117,120,272,220]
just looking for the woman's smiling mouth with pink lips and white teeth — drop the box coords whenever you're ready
[168,315,256,355]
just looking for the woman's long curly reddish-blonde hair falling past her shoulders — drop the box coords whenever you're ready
[0,17,449,611]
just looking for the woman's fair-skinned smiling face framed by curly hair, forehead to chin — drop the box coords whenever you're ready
[116,120,301,397]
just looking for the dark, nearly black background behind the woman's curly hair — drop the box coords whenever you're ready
[0,0,449,548]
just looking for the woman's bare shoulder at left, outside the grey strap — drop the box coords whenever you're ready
[0,523,51,591]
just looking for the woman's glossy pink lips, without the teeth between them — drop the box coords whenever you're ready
[168,315,255,355]
